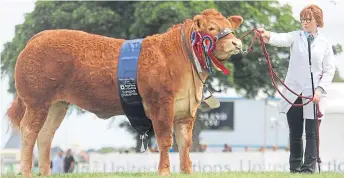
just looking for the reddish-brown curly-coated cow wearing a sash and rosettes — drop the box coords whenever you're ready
[7,9,243,177]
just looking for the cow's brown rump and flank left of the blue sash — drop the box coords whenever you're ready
[16,30,124,118]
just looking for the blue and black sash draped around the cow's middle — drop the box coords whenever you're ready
[117,39,152,139]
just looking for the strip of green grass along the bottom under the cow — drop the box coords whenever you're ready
[2,172,344,178]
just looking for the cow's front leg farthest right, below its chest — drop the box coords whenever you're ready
[174,117,195,174]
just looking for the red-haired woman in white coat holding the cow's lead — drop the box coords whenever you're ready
[258,5,335,173]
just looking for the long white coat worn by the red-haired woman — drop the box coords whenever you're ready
[267,31,336,119]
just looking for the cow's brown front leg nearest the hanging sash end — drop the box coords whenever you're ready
[150,101,174,176]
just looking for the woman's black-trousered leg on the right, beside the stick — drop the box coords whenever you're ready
[301,119,321,173]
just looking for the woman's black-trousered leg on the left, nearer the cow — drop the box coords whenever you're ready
[287,98,304,172]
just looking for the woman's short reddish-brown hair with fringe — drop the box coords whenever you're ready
[300,4,324,27]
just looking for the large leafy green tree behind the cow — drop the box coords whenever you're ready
[1,1,342,152]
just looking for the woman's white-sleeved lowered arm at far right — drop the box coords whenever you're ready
[318,44,336,91]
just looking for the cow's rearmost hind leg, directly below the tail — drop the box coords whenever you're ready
[20,104,49,177]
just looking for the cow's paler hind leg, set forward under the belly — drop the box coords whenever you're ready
[37,101,68,176]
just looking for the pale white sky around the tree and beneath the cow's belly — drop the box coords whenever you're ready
[0,0,344,149]
